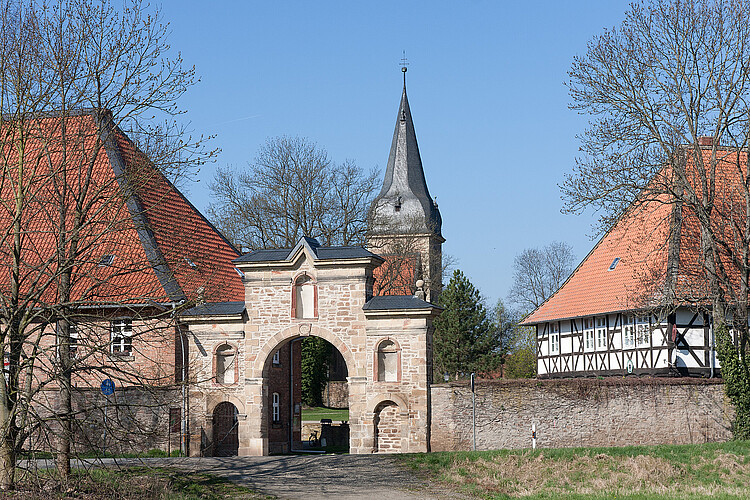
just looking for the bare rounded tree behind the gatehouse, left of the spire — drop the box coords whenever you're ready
[209,137,378,249]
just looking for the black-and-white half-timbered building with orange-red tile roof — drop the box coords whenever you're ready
[523,138,745,377]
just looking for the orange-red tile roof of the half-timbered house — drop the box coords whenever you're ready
[523,148,745,325]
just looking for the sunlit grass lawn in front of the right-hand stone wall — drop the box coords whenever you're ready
[399,441,750,500]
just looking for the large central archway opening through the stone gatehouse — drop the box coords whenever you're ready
[263,335,349,454]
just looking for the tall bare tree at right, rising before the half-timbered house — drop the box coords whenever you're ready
[562,0,750,435]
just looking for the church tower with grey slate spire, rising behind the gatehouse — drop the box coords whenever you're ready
[369,67,445,302]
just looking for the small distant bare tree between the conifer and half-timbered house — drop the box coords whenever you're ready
[508,241,575,312]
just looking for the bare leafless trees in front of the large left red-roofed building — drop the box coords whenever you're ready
[0,0,210,489]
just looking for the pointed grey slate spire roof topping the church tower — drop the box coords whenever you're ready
[374,67,442,235]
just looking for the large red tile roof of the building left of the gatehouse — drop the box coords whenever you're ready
[0,114,244,304]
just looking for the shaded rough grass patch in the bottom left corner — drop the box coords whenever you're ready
[0,467,274,500]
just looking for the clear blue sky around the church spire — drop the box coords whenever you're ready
[162,0,628,304]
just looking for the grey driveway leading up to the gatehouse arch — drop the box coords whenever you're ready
[170,455,466,500]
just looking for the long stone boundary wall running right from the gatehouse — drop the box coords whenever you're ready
[430,377,734,451]
